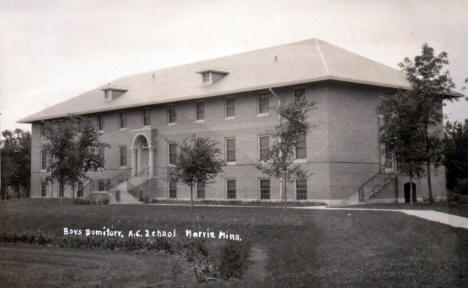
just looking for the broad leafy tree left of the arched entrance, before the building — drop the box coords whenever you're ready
[43,116,109,199]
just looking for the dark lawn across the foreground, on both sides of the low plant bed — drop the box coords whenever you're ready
[0,199,468,287]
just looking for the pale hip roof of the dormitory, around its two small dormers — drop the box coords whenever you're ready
[19,39,409,123]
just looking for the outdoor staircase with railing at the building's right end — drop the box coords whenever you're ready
[346,171,398,205]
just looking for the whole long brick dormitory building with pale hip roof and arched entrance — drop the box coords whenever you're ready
[20,39,445,203]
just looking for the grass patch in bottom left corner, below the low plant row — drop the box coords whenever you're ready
[0,245,193,287]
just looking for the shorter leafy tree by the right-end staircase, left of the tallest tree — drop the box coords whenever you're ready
[378,90,425,204]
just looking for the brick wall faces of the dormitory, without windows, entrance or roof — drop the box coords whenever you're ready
[31,81,445,200]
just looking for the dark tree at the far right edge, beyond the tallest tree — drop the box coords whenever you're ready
[444,120,468,191]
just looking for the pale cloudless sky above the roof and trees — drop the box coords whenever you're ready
[0,0,468,130]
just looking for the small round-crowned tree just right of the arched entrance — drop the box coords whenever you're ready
[170,135,225,209]
